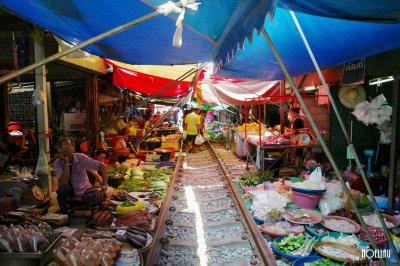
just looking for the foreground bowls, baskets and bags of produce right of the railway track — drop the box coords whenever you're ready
[237,168,400,265]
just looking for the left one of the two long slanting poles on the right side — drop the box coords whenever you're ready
[262,28,384,265]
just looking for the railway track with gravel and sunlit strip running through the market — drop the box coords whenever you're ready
[146,142,276,266]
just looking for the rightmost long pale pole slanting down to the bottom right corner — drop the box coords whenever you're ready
[290,11,400,261]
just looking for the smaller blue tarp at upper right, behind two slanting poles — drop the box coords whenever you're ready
[217,8,400,80]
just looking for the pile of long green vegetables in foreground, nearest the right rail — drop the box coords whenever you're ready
[274,234,318,256]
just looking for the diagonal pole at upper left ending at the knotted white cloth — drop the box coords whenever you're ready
[0,11,161,84]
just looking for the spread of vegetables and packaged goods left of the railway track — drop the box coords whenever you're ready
[0,153,178,266]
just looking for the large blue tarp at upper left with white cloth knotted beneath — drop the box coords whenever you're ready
[0,0,271,65]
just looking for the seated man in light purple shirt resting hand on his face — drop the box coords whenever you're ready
[54,137,108,213]
